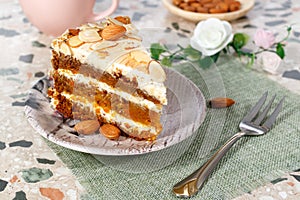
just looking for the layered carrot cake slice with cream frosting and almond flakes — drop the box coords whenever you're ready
[48,16,167,140]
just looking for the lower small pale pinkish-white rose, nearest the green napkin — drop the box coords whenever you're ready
[257,51,281,74]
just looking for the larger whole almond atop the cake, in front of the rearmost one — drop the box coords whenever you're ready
[101,24,126,40]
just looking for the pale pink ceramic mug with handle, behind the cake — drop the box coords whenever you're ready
[19,0,119,36]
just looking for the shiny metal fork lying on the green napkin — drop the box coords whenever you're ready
[173,92,284,198]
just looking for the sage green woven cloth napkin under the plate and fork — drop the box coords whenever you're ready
[48,58,300,199]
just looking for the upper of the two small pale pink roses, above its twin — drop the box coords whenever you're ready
[254,29,275,49]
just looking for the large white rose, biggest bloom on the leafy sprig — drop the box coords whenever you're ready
[190,18,233,56]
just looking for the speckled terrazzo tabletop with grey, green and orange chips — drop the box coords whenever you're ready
[0,0,300,200]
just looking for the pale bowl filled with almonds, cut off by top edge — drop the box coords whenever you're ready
[162,0,255,22]
